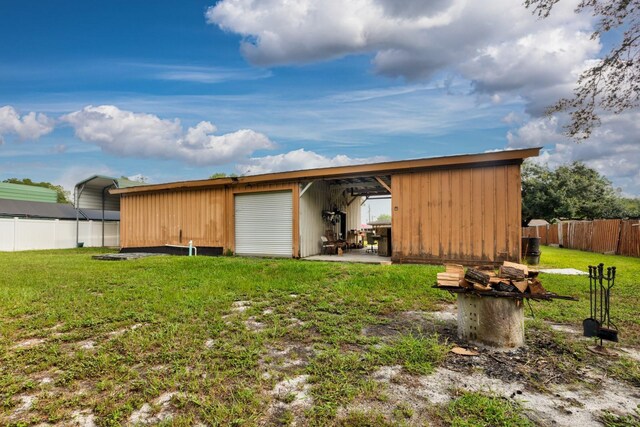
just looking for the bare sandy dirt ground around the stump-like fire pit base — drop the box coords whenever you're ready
[352,306,640,426]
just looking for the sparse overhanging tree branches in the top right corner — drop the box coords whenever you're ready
[525,0,640,142]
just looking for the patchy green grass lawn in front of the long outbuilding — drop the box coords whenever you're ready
[0,247,640,426]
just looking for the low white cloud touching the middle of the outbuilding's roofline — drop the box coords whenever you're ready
[236,149,388,175]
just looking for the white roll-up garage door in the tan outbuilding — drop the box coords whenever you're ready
[235,191,293,257]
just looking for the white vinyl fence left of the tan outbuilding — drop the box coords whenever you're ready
[0,218,120,252]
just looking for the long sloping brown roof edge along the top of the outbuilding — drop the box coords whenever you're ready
[109,147,542,194]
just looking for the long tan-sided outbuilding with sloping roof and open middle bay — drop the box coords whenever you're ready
[109,148,540,264]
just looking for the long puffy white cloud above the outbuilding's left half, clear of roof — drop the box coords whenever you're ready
[61,105,274,166]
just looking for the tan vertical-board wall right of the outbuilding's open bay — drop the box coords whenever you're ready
[391,164,521,264]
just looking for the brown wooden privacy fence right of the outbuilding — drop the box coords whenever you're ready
[522,219,640,257]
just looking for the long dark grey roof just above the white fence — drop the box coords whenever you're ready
[0,199,120,221]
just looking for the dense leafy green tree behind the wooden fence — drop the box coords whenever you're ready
[522,162,630,223]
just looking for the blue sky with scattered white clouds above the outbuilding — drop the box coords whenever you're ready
[0,0,640,208]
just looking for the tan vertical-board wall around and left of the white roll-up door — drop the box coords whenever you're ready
[120,183,299,256]
